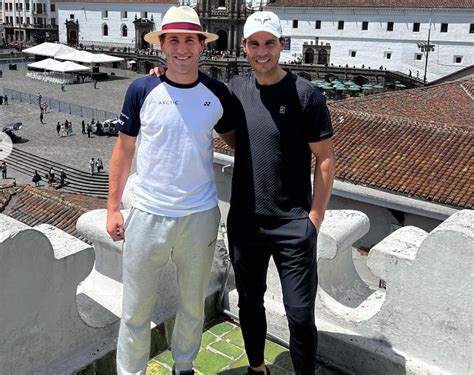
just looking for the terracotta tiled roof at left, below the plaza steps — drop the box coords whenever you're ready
[0,185,107,241]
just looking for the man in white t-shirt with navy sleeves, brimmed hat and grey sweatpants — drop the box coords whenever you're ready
[107,6,235,374]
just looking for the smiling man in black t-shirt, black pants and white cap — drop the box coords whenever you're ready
[226,12,334,375]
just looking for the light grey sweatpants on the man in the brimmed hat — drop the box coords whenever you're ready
[117,207,220,375]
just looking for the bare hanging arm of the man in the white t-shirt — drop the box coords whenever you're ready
[107,133,136,241]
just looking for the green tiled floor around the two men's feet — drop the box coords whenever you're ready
[147,322,338,375]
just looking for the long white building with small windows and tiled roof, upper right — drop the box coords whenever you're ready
[266,0,474,81]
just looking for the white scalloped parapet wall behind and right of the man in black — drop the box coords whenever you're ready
[229,210,474,375]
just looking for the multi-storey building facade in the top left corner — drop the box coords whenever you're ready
[1,0,58,45]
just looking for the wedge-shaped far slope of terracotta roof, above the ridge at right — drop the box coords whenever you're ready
[330,80,474,130]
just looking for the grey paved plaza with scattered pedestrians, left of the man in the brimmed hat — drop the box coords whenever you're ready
[0,63,139,187]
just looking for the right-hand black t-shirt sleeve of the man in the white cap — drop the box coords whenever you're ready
[303,89,333,142]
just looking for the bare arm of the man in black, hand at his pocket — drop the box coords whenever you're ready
[309,138,336,232]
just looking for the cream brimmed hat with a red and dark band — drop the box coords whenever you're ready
[145,6,219,44]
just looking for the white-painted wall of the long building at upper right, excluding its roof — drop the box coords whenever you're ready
[267,6,474,80]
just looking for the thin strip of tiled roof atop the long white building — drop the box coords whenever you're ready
[269,0,474,9]
